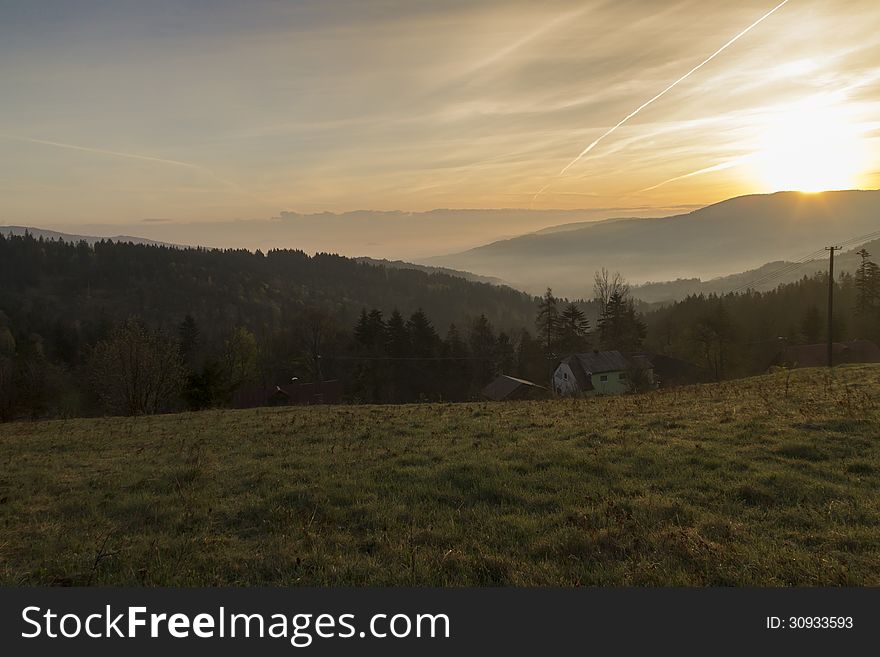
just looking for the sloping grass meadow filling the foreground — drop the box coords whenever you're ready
[0,366,880,586]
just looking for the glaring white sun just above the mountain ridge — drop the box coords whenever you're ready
[753,101,866,192]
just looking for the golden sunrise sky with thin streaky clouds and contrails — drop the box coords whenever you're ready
[0,0,880,257]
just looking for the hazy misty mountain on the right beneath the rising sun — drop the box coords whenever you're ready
[424,191,880,297]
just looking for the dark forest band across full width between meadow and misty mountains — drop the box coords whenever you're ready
[0,236,880,420]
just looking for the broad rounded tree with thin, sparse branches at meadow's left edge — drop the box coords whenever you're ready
[89,319,186,415]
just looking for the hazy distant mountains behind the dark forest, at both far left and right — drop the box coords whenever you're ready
[10,191,880,303]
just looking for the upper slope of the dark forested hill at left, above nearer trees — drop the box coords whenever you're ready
[0,235,534,356]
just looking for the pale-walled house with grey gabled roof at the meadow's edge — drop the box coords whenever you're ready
[553,351,654,397]
